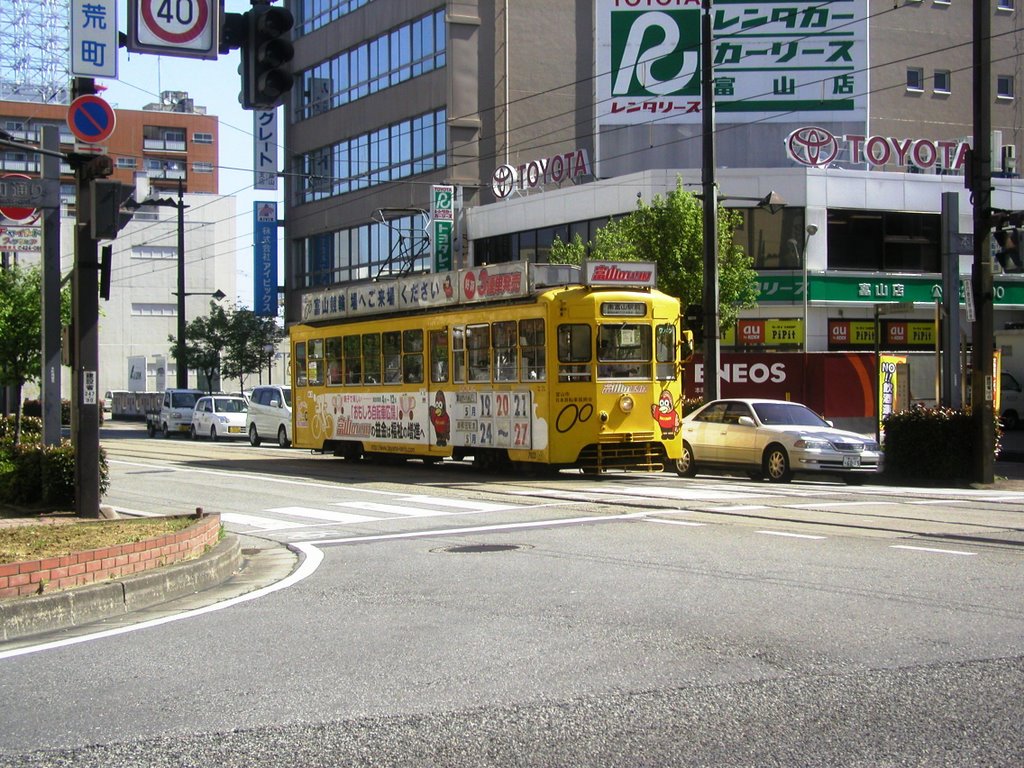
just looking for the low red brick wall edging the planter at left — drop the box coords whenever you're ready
[0,514,220,598]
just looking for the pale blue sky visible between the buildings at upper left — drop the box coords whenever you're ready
[96,0,284,307]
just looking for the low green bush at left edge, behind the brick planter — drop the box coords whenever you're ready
[0,440,110,508]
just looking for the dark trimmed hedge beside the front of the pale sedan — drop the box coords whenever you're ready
[883,404,1001,480]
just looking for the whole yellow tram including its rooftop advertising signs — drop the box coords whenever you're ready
[290,261,692,472]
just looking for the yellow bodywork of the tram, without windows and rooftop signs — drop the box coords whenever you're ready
[290,287,682,466]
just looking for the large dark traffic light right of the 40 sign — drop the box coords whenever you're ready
[239,3,295,110]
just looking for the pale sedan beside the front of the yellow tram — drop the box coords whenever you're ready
[676,398,882,483]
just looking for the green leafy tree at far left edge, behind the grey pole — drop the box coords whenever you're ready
[0,264,71,444]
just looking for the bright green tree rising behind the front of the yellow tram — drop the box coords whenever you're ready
[550,179,758,329]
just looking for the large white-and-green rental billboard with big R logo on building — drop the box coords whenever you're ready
[595,0,869,124]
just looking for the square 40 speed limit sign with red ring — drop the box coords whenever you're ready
[128,0,220,58]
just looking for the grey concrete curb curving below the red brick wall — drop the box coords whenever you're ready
[0,535,242,642]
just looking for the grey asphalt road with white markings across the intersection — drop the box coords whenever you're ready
[0,430,1024,768]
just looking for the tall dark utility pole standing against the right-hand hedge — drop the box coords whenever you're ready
[968,0,995,483]
